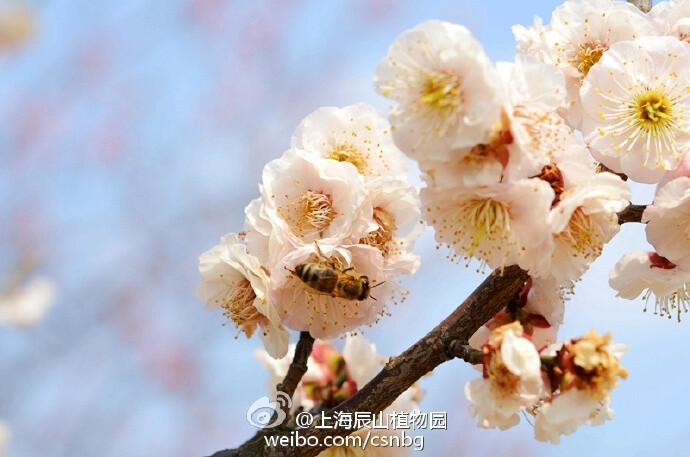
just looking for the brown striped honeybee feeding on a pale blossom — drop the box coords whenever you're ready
[290,244,383,301]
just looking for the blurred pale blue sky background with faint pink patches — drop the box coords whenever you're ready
[0,0,690,457]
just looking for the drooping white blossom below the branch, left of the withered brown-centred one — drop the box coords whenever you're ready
[465,322,544,430]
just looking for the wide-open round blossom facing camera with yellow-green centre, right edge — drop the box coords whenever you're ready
[581,37,690,183]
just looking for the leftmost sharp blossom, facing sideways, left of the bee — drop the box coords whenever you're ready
[196,233,290,358]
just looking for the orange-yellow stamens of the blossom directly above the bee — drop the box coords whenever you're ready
[278,190,336,238]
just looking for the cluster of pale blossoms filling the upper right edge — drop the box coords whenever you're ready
[514,0,690,320]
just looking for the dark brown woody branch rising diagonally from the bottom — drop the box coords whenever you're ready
[208,199,646,457]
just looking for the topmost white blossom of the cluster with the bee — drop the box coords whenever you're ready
[291,103,407,180]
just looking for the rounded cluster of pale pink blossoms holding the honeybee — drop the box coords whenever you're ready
[197,104,423,358]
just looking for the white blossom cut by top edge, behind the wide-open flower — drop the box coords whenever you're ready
[543,0,654,129]
